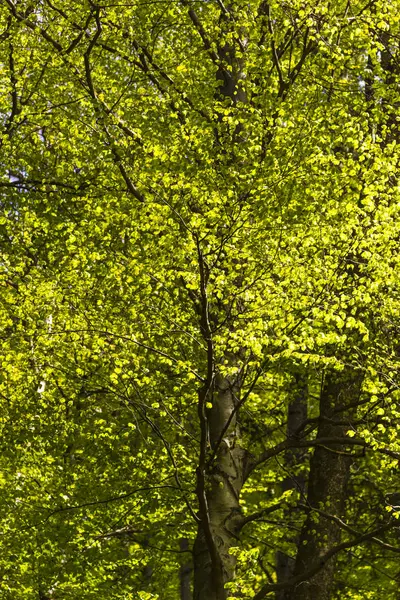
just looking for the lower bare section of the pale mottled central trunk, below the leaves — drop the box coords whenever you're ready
[193,375,245,600]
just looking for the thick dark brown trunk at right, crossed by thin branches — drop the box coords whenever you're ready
[286,373,361,600]
